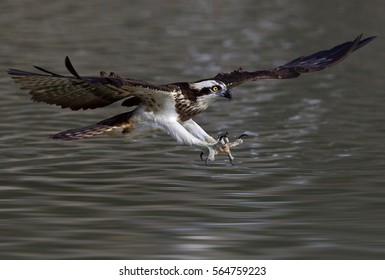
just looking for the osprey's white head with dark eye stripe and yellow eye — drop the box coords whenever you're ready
[189,80,232,107]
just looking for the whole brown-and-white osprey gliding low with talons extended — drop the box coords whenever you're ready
[8,34,375,164]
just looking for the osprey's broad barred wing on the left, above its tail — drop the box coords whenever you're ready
[8,57,172,110]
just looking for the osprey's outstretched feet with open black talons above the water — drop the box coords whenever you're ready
[200,132,247,165]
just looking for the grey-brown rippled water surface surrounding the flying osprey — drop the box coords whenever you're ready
[0,0,385,259]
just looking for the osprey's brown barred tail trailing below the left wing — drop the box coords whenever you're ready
[50,111,134,140]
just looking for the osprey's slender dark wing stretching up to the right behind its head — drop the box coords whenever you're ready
[214,34,376,88]
